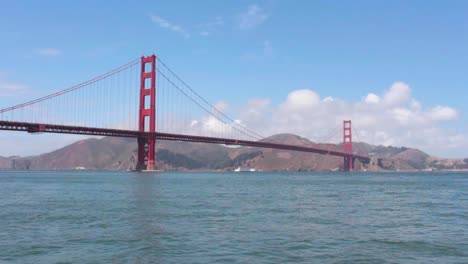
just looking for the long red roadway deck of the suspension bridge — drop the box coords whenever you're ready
[0,121,370,163]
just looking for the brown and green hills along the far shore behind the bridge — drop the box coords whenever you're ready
[0,134,468,171]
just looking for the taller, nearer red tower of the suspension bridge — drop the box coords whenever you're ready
[136,55,156,171]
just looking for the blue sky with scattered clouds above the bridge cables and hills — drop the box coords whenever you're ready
[0,1,468,157]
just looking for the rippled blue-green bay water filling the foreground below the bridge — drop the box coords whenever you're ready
[0,171,468,263]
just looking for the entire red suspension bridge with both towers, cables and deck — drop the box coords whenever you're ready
[0,55,370,171]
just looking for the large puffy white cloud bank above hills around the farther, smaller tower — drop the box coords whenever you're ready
[233,82,468,157]
